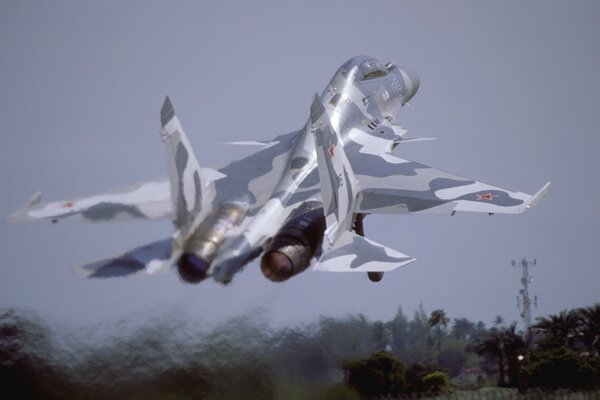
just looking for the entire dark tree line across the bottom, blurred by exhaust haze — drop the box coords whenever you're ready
[0,304,600,399]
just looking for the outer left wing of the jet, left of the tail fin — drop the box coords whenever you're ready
[6,181,172,223]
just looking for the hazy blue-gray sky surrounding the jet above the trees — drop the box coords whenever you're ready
[0,0,600,332]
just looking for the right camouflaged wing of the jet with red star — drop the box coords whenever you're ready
[349,152,550,215]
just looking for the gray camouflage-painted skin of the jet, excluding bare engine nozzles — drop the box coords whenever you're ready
[9,56,549,282]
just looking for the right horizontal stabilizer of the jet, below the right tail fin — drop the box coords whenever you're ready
[314,231,415,272]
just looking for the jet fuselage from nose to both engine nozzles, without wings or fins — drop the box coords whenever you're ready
[179,56,419,282]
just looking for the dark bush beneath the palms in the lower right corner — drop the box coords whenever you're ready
[521,346,600,390]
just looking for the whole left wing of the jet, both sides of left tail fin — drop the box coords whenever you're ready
[6,132,297,227]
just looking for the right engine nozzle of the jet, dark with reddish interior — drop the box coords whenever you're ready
[260,202,325,282]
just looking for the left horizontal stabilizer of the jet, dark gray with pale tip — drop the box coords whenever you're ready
[73,238,173,278]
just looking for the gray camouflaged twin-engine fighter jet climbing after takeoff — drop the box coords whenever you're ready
[8,56,550,283]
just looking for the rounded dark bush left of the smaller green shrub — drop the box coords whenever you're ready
[344,351,406,398]
